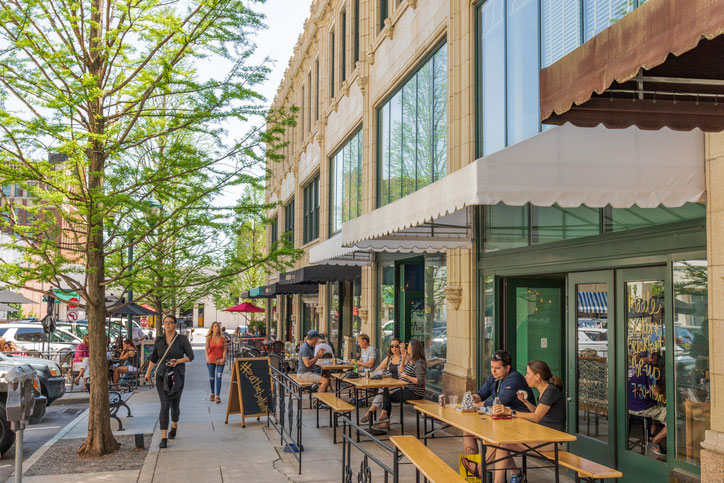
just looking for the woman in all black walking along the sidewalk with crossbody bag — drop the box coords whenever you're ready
[146,314,194,448]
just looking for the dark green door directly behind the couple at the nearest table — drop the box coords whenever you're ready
[505,278,566,399]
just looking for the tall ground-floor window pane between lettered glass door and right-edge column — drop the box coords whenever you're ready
[673,260,711,465]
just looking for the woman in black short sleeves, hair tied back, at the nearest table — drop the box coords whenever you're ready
[487,361,566,483]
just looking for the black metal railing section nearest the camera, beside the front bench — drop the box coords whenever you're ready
[339,415,407,483]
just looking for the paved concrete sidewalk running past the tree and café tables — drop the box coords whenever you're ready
[14,334,572,483]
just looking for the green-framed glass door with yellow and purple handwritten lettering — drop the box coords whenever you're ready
[616,267,673,481]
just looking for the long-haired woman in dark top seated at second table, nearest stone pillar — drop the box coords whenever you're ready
[375,339,427,429]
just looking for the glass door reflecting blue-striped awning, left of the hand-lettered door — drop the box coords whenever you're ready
[566,271,616,466]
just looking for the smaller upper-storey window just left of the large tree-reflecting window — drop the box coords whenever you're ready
[329,129,362,233]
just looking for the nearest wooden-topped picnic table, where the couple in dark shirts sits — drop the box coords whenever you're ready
[415,404,576,482]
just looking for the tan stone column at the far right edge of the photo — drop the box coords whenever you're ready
[701,133,724,481]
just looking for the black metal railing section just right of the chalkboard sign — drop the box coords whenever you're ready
[267,367,304,475]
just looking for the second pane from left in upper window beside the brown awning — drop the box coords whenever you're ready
[506,0,540,145]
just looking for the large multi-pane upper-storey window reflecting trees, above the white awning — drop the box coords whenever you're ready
[377,45,447,206]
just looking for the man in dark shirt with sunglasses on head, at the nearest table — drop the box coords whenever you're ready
[463,350,535,480]
